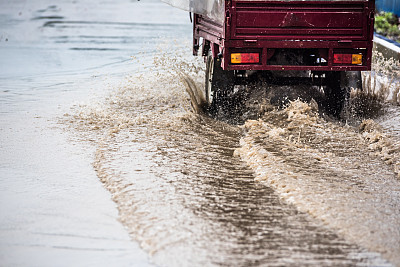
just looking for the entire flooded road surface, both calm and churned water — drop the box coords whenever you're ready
[1,1,400,266]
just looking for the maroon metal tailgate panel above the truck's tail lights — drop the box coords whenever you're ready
[230,0,373,40]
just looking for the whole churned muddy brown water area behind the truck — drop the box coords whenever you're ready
[64,47,400,266]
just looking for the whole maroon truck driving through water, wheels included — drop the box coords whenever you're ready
[193,0,375,115]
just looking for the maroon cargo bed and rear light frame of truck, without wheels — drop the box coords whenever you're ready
[193,0,375,71]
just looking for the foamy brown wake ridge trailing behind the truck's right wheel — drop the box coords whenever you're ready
[235,101,400,263]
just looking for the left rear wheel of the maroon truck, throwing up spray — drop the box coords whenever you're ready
[204,51,235,110]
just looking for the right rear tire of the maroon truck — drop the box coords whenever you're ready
[324,71,362,118]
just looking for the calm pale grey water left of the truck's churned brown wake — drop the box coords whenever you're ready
[0,0,191,266]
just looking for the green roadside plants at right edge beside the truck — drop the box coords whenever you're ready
[375,12,400,43]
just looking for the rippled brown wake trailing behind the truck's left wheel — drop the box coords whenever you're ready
[66,56,387,266]
